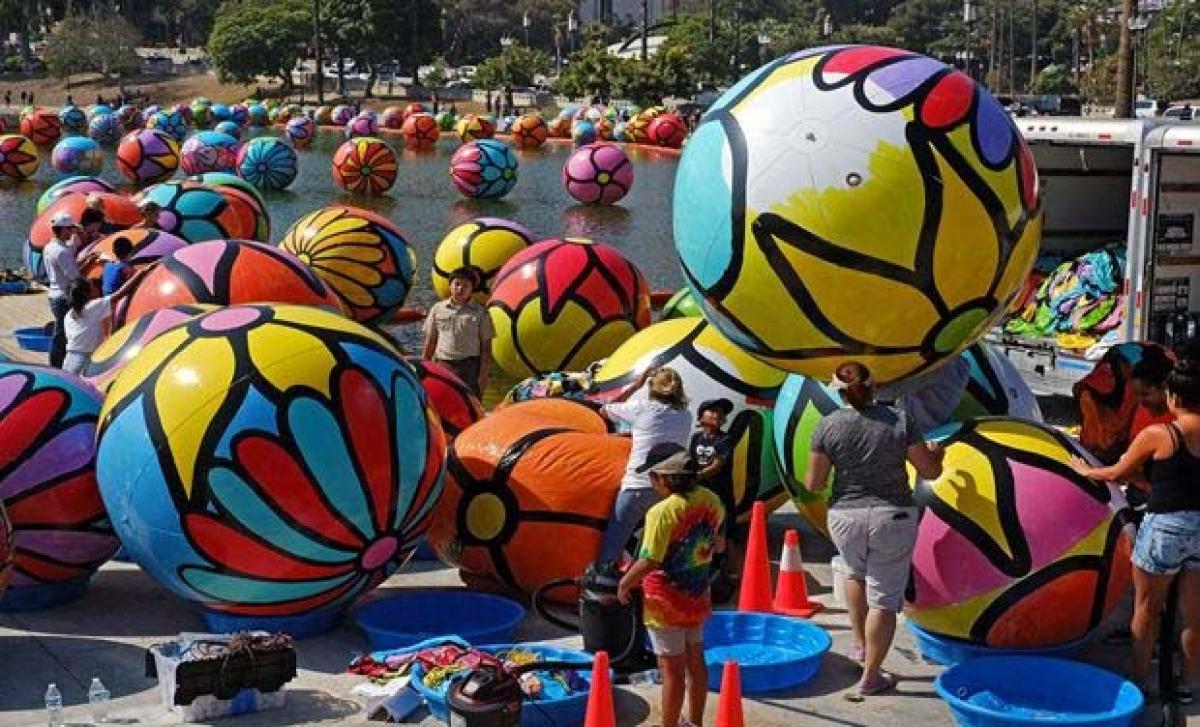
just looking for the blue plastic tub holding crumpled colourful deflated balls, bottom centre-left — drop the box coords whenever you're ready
[410,644,592,727]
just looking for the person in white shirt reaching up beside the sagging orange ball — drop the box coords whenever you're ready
[599,367,691,560]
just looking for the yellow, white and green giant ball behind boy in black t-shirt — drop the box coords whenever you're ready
[588,318,787,521]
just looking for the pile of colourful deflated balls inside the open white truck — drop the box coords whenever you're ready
[1004,244,1126,348]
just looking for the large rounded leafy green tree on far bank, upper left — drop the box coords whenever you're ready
[208,0,312,94]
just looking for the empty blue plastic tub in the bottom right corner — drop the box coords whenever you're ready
[934,656,1144,727]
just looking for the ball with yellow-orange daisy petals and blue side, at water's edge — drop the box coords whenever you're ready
[280,206,416,323]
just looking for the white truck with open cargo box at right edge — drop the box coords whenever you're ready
[988,118,1200,396]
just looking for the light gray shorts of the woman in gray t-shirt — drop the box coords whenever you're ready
[828,505,917,612]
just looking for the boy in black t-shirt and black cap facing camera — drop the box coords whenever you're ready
[688,398,745,597]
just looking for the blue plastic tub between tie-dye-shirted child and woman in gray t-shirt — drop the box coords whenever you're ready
[704,611,833,695]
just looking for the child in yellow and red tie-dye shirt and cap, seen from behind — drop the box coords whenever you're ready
[617,444,725,727]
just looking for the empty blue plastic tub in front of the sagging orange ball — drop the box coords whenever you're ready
[354,588,526,650]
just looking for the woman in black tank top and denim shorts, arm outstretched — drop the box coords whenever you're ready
[1072,358,1200,703]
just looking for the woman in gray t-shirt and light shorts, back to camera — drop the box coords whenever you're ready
[804,361,942,702]
